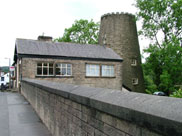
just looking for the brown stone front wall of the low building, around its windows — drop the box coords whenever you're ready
[20,58,122,90]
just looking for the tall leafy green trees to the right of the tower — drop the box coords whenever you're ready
[136,0,182,95]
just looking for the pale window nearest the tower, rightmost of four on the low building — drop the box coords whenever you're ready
[102,65,114,77]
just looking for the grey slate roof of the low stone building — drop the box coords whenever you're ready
[16,39,122,60]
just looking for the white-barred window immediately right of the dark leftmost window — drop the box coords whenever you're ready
[56,63,72,76]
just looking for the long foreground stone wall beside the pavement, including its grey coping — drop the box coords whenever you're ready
[21,79,182,136]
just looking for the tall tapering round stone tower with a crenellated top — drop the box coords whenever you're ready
[99,12,144,92]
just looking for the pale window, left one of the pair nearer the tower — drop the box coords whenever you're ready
[86,64,100,76]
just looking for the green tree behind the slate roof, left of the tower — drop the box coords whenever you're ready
[55,19,99,44]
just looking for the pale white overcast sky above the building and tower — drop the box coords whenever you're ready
[0,0,148,66]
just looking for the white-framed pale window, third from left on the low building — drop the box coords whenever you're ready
[85,64,100,77]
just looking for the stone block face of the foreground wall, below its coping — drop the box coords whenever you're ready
[22,82,164,136]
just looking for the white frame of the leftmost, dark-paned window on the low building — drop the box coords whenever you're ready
[37,62,54,76]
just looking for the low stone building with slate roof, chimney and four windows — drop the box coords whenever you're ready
[14,37,122,90]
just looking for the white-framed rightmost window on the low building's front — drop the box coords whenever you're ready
[101,65,115,77]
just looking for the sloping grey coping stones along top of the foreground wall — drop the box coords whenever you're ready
[22,78,182,136]
